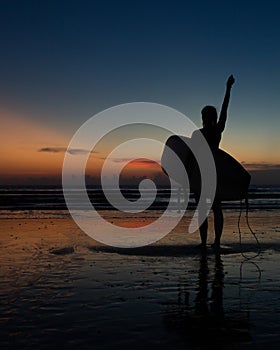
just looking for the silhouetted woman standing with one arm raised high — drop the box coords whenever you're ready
[192,75,235,248]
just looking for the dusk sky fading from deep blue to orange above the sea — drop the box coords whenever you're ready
[0,0,280,185]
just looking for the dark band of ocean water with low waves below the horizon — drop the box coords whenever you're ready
[0,186,280,211]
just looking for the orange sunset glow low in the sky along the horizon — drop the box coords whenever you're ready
[0,110,280,183]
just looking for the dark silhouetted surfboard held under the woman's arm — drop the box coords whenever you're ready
[161,135,251,201]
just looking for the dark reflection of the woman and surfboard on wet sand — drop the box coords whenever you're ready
[163,254,251,349]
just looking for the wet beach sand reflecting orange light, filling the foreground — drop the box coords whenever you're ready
[0,210,280,350]
